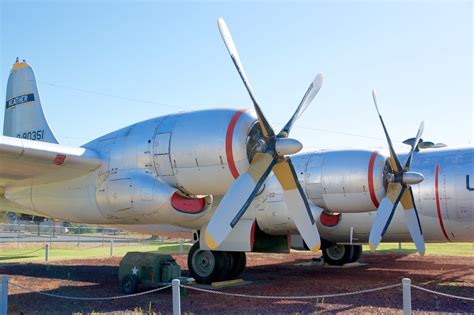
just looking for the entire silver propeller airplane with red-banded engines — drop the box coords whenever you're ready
[0,19,474,283]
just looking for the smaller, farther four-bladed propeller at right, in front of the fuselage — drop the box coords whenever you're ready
[369,90,425,255]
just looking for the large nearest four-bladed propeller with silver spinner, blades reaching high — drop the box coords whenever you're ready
[204,18,322,251]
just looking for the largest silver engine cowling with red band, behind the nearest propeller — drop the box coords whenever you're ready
[153,109,256,195]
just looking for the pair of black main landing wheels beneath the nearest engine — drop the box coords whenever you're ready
[188,242,246,284]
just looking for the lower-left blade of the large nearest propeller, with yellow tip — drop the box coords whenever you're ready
[204,153,276,249]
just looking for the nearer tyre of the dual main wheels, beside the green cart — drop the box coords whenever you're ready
[188,242,227,284]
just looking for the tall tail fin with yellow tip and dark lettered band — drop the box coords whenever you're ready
[3,58,58,143]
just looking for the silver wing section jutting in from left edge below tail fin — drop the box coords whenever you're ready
[0,136,101,188]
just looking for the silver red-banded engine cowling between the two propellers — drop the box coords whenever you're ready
[304,150,386,212]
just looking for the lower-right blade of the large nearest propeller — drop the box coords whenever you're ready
[273,158,321,252]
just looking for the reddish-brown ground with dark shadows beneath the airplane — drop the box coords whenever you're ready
[0,252,474,314]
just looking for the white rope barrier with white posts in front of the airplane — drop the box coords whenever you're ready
[0,276,474,315]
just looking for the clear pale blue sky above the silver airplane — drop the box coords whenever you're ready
[0,0,473,149]
